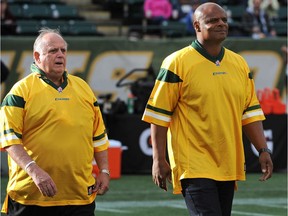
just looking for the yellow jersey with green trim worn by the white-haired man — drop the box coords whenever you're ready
[0,64,109,211]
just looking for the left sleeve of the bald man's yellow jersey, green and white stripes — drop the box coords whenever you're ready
[142,56,182,127]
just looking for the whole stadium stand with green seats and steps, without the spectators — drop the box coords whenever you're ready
[3,0,287,37]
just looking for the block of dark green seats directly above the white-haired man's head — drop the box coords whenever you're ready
[8,0,104,36]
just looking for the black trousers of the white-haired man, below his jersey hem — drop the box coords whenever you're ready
[7,197,95,216]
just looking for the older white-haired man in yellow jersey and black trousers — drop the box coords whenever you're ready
[0,28,109,216]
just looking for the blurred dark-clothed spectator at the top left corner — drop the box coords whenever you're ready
[0,0,17,35]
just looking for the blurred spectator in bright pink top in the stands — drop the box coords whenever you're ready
[143,0,172,25]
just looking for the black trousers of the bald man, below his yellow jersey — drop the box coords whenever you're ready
[181,178,235,216]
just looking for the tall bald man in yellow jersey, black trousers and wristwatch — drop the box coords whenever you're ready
[142,3,273,216]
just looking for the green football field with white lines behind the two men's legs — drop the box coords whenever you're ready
[1,172,287,216]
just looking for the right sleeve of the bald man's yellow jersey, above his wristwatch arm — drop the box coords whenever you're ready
[242,59,265,125]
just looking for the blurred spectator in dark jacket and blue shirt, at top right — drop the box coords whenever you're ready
[242,0,276,39]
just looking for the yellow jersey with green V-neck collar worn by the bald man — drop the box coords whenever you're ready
[142,40,265,193]
